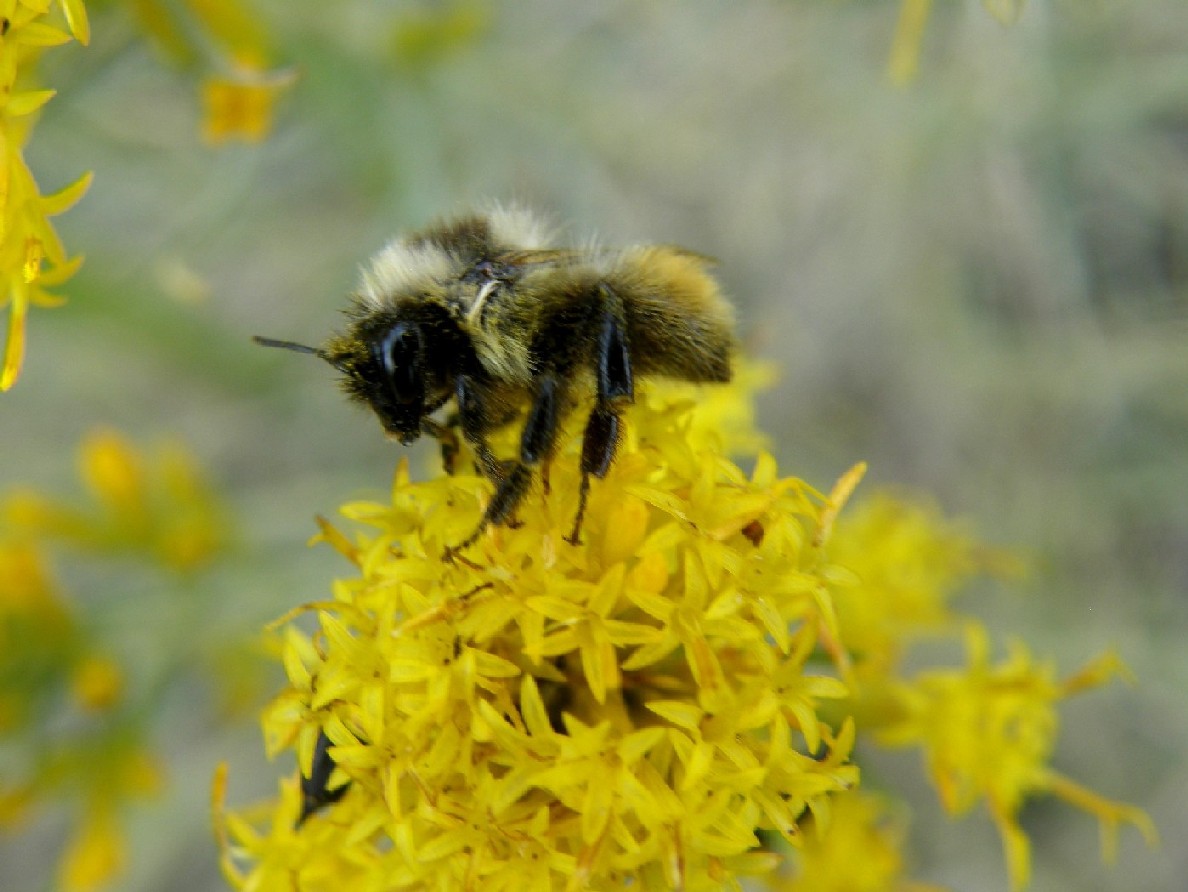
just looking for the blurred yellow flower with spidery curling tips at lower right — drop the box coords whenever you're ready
[879,624,1155,890]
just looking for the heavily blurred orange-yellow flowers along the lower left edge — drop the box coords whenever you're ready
[0,431,226,892]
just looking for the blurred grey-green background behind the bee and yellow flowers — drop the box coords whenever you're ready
[0,0,1188,892]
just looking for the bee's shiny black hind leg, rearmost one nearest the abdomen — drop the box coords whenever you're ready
[565,301,636,545]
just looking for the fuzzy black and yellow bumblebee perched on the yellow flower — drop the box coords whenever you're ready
[255,208,734,557]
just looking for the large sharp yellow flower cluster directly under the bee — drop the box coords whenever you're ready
[220,385,858,890]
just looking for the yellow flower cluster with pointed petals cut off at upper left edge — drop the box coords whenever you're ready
[0,0,90,391]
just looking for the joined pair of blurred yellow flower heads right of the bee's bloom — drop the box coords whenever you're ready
[832,495,1156,888]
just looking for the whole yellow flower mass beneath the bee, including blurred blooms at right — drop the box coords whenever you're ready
[216,374,1149,892]
